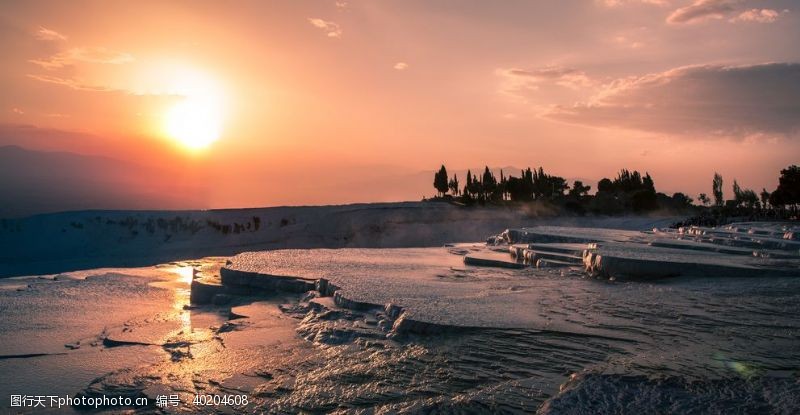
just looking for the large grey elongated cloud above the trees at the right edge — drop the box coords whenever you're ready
[545,63,800,137]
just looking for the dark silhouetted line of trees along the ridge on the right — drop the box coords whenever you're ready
[433,165,800,218]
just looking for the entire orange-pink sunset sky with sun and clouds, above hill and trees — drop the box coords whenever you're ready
[0,0,800,213]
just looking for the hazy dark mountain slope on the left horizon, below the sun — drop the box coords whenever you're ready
[0,146,204,218]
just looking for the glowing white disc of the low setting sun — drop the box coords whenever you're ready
[164,97,222,150]
